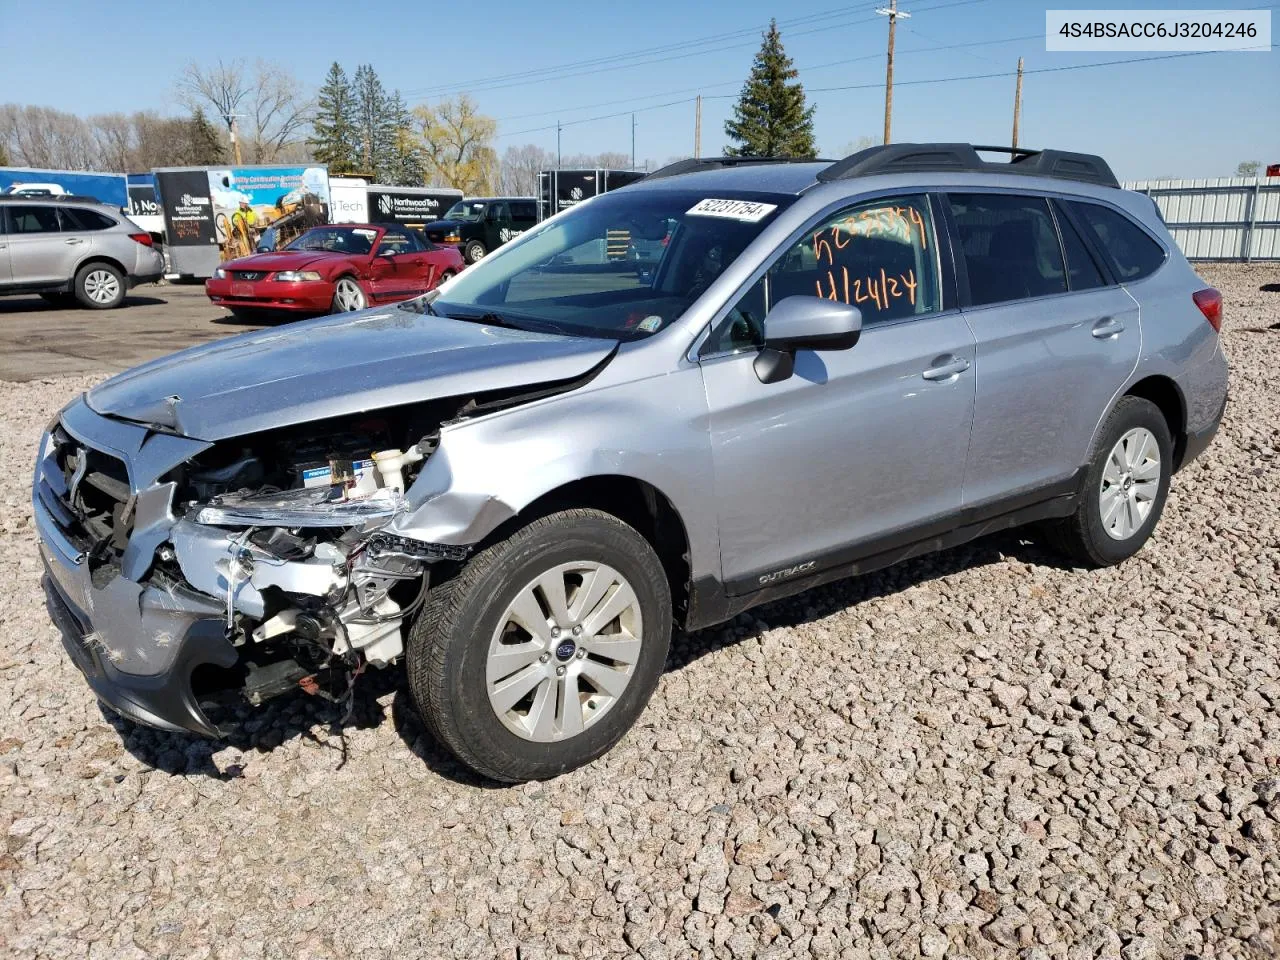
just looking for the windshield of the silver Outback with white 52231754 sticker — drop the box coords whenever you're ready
[431,189,795,339]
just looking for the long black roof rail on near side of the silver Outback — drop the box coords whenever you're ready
[818,143,1120,187]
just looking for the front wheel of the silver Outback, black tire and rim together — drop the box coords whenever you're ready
[406,509,671,782]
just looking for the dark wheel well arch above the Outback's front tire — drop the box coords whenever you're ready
[503,476,690,623]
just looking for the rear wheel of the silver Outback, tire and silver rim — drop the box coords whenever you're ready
[1046,397,1174,567]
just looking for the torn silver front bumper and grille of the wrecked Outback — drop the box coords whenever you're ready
[32,401,465,737]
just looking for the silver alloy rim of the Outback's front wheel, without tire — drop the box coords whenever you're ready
[485,561,644,742]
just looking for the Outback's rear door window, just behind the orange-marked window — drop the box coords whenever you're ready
[950,193,1066,306]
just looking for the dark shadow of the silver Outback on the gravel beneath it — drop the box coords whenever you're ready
[102,531,1070,790]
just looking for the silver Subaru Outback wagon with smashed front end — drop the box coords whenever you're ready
[33,145,1228,781]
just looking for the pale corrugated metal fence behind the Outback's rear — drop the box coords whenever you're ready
[1124,177,1280,260]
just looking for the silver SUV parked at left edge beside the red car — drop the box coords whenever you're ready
[0,195,164,310]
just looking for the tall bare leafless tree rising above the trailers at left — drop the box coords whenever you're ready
[178,59,311,163]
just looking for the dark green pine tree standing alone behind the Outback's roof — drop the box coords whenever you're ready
[724,20,818,157]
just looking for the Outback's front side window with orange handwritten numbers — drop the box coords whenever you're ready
[701,196,942,356]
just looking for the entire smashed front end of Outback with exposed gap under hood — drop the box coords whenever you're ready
[33,360,611,735]
